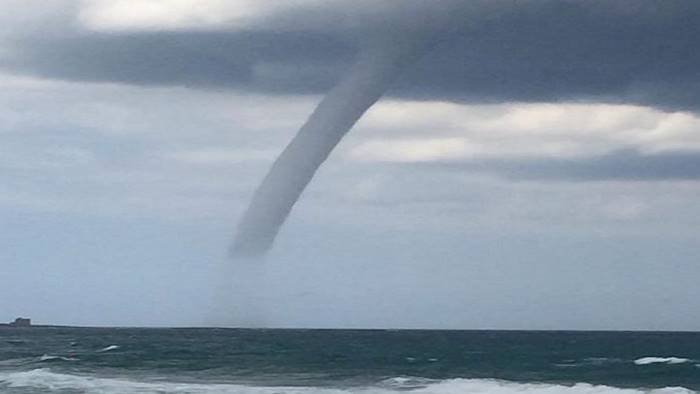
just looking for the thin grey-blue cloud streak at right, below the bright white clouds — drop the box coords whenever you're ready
[428,150,700,181]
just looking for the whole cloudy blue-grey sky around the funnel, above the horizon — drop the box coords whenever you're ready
[0,0,700,330]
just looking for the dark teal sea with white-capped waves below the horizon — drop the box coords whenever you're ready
[0,328,700,394]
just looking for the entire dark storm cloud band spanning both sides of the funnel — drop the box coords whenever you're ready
[0,0,700,110]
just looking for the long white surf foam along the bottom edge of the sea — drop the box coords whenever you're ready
[0,369,695,394]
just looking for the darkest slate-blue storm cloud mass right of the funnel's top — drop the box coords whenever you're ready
[396,2,700,109]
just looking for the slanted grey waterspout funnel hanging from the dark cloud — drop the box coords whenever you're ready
[232,39,434,256]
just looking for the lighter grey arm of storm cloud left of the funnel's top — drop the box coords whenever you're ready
[0,32,352,93]
